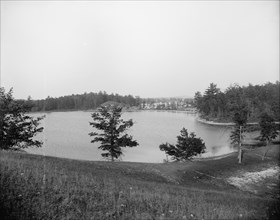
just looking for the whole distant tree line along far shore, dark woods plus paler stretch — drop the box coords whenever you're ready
[26,91,196,112]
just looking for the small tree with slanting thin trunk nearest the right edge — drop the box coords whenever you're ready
[259,112,278,160]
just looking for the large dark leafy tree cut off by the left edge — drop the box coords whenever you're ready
[0,87,43,150]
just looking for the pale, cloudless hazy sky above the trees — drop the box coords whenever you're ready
[1,1,279,99]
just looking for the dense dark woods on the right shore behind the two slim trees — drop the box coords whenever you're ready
[194,81,280,122]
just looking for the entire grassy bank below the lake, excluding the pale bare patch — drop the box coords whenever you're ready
[0,145,280,219]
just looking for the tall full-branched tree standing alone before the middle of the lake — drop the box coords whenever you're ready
[89,104,138,161]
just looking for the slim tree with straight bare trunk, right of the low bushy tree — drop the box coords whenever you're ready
[230,106,248,164]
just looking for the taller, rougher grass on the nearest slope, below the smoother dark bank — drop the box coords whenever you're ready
[0,151,277,219]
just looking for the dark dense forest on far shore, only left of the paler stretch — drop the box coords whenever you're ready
[27,92,140,112]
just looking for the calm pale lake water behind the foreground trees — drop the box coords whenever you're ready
[28,111,233,162]
